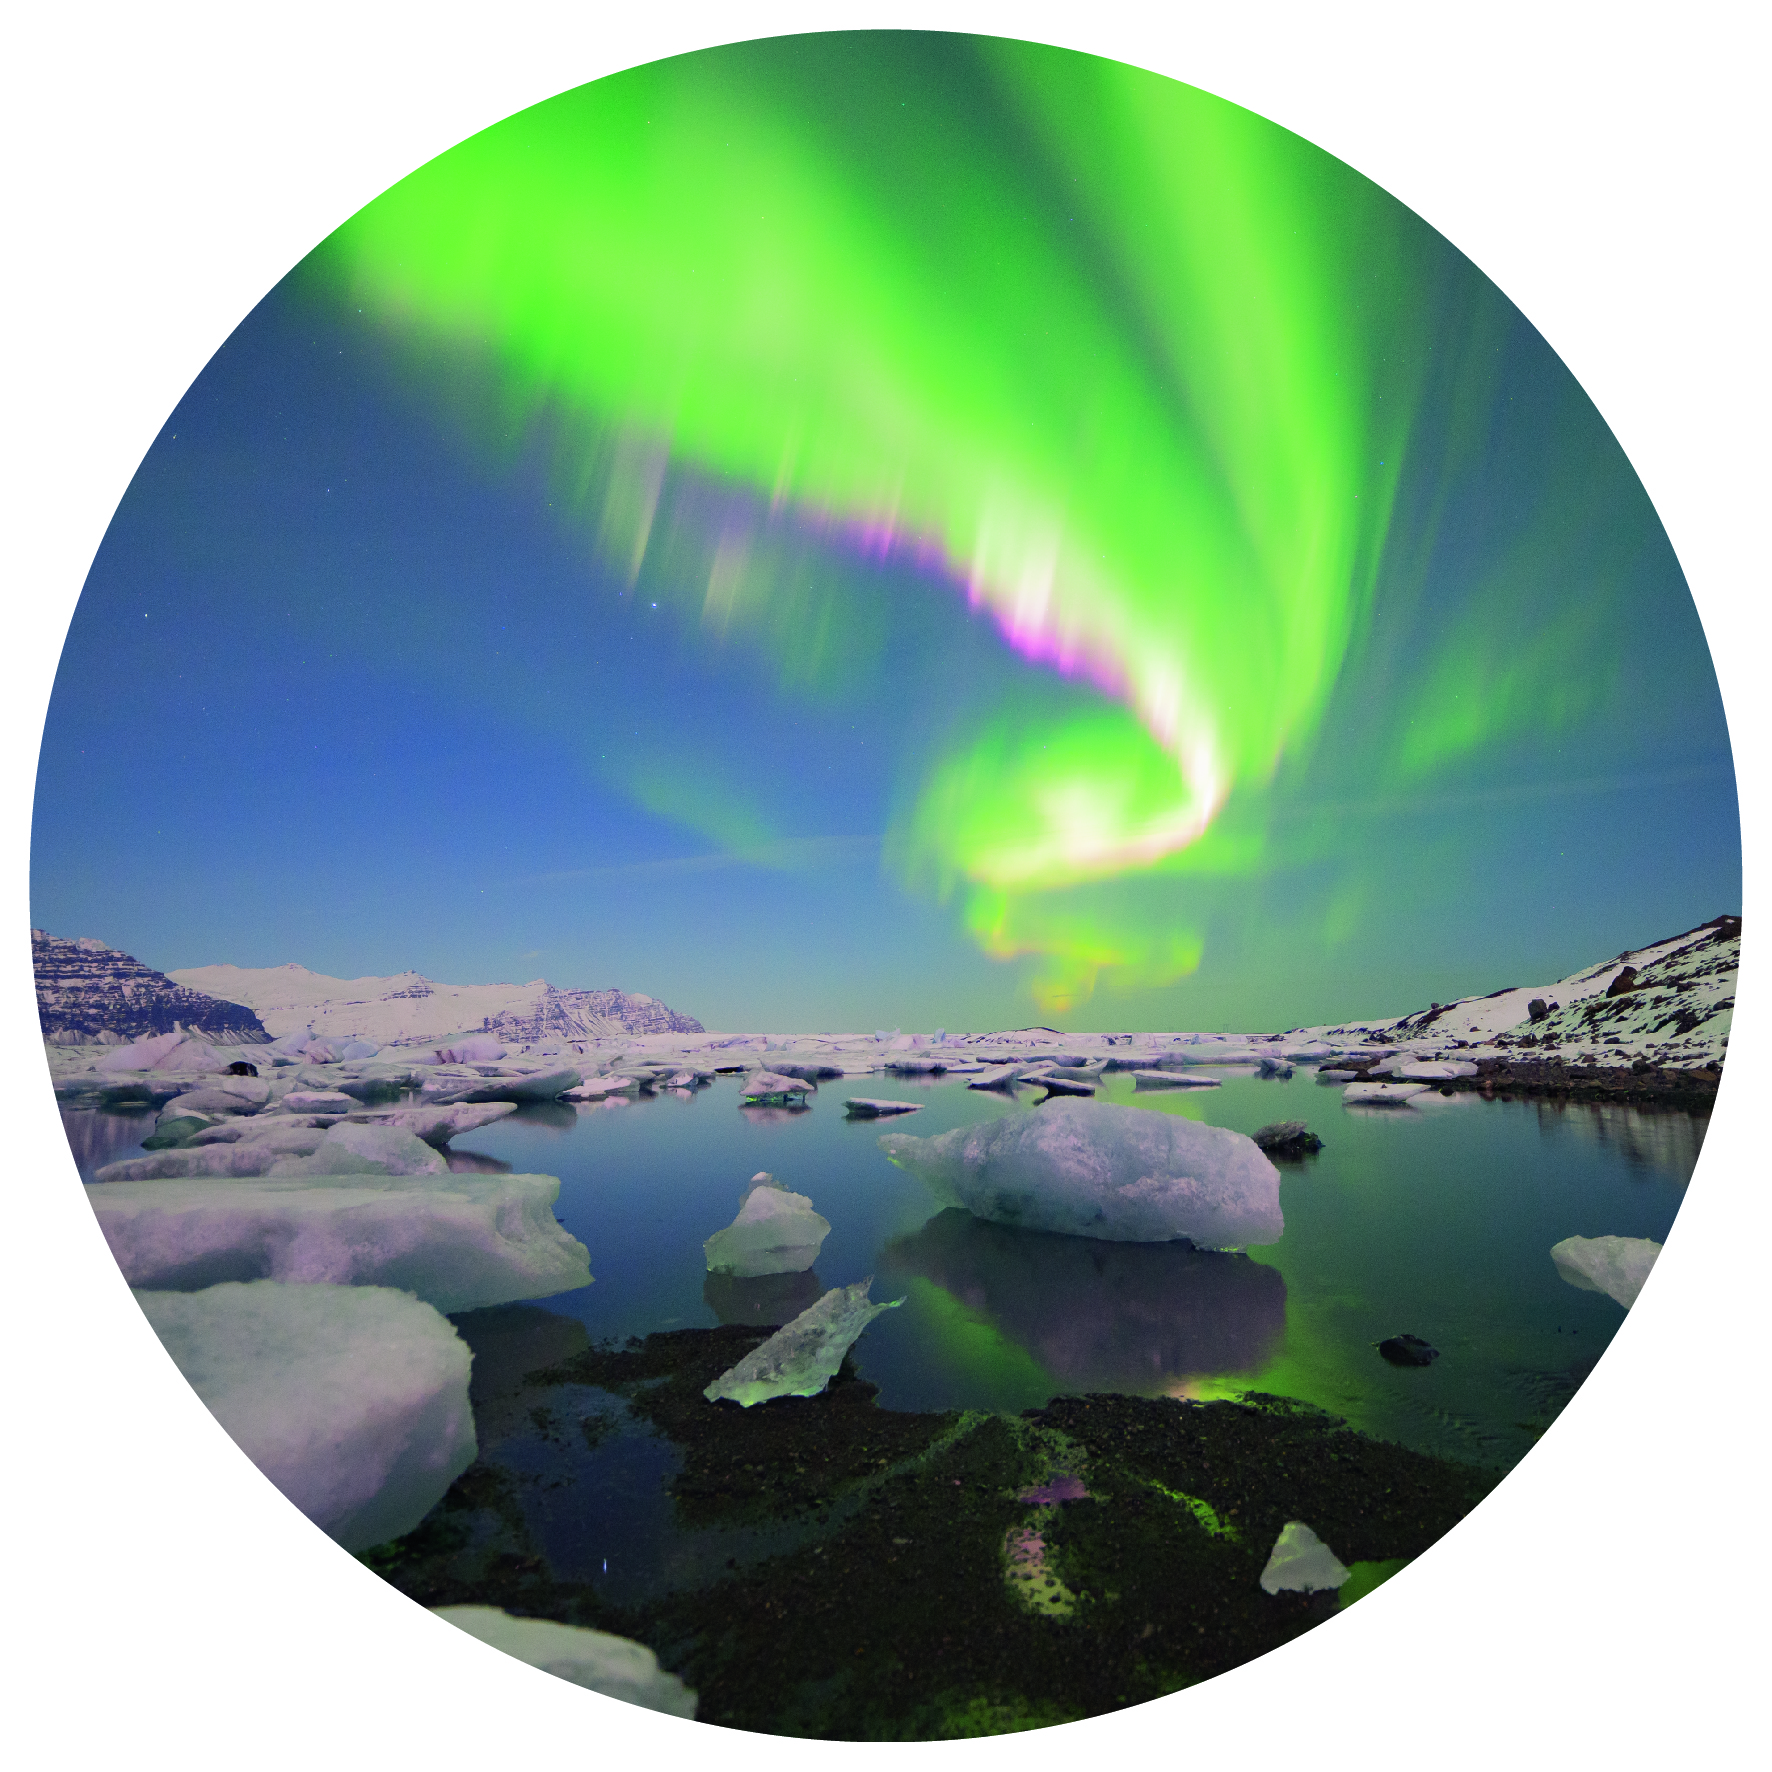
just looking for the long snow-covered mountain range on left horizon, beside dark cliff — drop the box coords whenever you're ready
[168,964,702,1045]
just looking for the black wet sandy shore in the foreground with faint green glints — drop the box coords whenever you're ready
[363,1311,1501,1740]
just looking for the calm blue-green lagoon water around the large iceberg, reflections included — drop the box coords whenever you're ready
[66,1069,1705,1467]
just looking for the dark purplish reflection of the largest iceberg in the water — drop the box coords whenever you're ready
[882,1209,1286,1391]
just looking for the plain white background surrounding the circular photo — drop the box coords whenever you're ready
[0,0,1772,1767]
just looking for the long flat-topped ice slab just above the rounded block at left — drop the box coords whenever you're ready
[87,1176,590,1311]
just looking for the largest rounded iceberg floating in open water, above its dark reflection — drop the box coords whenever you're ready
[879,1099,1285,1249]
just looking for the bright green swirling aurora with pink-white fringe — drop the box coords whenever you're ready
[301,34,1714,1015]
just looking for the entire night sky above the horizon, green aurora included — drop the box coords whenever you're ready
[39,34,1738,1026]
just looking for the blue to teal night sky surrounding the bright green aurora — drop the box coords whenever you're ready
[32,39,1740,1030]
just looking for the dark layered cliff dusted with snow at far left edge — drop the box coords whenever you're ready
[30,929,269,1045]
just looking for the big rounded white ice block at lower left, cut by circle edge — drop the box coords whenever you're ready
[135,1279,475,1551]
